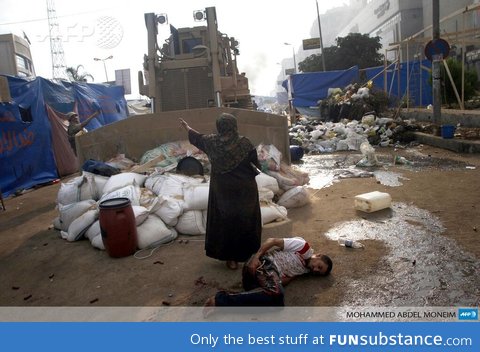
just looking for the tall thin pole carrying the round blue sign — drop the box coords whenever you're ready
[432,0,443,124]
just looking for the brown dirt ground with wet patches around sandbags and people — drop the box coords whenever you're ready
[0,146,480,307]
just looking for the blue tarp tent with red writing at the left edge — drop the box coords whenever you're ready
[0,76,128,196]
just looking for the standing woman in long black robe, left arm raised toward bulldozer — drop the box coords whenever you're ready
[180,113,262,269]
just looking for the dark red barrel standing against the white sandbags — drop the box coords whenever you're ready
[99,198,137,258]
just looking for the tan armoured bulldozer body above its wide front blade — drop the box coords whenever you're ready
[138,7,253,113]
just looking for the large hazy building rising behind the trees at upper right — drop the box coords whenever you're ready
[277,0,480,96]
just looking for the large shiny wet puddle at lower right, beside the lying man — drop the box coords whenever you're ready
[325,203,480,307]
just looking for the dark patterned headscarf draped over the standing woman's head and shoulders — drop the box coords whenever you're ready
[205,113,255,173]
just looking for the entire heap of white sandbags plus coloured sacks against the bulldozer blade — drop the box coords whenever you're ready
[53,141,309,250]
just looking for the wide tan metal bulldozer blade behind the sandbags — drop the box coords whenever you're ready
[77,108,290,165]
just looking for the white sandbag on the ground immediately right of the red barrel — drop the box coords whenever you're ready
[137,214,177,249]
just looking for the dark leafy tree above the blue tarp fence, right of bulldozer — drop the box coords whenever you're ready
[298,33,383,72]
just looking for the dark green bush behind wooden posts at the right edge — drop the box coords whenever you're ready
[441,58,477,105]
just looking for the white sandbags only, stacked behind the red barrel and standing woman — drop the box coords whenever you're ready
[54,153,308,249]
